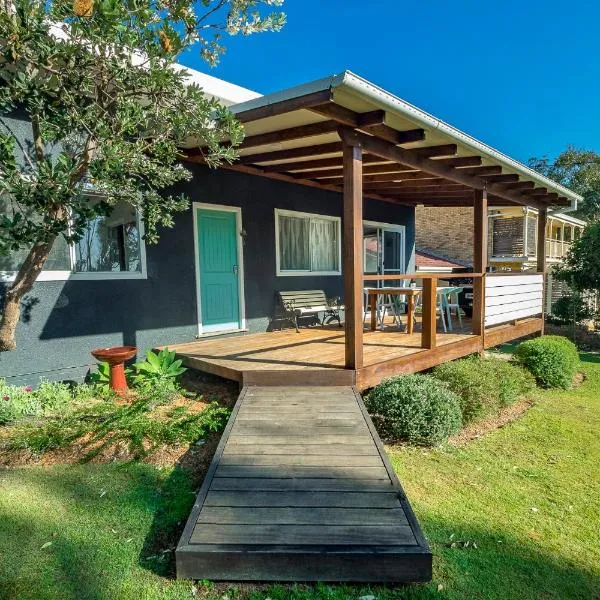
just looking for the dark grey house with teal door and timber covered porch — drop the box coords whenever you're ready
[0,72,580,389]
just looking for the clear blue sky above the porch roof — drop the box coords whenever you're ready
[181,0,600,161]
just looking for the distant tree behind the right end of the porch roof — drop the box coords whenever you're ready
[528,146,600,220]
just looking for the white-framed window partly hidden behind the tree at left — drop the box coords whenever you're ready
[0,197,146,281]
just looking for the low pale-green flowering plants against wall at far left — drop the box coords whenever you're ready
[0,379,74,425]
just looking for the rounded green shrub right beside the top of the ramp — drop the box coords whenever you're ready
[365,375,462,446]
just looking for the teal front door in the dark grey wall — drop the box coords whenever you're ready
[196,208,241,333]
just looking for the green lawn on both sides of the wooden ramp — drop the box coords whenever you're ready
[0,355,600,600]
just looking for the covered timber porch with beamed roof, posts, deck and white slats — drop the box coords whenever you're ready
[179,72,577,389]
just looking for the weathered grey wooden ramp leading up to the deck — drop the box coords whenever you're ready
[176,386,431,582]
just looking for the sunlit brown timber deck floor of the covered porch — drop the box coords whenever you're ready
[169,327,481,390]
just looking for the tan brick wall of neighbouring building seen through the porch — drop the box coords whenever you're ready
[415,206,473,264]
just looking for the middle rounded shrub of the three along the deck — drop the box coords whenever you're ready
[432,356,535,424]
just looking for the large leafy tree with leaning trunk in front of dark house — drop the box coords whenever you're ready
[0,0,285,351]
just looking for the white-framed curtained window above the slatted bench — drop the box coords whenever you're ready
[275,209,341,275]
